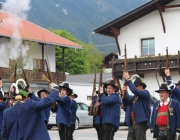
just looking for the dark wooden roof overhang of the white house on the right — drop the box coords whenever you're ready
[93,0,174,37]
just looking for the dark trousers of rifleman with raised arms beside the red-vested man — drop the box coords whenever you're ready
[127,122,147,140]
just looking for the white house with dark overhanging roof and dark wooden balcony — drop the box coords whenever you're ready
[93,0,180,97]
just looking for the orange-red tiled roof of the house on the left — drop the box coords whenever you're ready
[0,10,83,49]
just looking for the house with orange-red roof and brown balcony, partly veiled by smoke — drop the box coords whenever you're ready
[0,10,82,91]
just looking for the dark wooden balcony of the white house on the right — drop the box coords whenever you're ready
[112,54,180,79]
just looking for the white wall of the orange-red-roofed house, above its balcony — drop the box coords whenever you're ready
[0,38,56,72]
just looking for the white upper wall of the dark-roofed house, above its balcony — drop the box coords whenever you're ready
[118,0,180,58]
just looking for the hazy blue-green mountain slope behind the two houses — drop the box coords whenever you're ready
[2,0,149,53]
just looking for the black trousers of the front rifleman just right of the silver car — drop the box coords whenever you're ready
[102,123,117,140]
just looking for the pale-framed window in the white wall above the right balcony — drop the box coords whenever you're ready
[141,38,155,56]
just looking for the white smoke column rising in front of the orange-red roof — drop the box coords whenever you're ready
[0,0,31,60]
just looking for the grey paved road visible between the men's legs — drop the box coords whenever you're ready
[49,127,152,140]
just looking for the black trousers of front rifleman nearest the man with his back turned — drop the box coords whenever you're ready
[58,123,70,140]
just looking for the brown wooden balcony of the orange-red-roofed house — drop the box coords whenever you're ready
[0,67,66,83]
